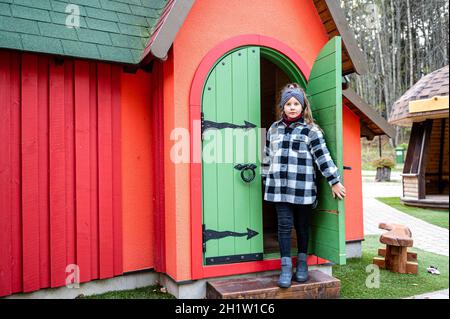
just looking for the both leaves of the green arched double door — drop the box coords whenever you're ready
[202,37,346,265]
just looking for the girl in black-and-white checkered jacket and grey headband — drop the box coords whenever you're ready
[261,83,345,288]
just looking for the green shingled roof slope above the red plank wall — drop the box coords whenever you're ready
[0,0,169,64]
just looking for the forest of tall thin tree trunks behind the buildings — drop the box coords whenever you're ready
[340,0,449,168]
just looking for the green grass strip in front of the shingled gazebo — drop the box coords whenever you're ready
[376,197,448,229]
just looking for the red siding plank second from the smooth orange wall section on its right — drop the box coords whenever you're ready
[98,63,114,278]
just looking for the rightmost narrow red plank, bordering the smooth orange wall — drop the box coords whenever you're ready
[111,66,123,276]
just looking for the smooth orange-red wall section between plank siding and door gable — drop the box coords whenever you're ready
[121,61,165,272]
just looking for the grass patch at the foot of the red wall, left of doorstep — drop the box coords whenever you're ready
[80,286,175,299]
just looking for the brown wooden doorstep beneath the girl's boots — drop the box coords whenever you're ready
[206,270,341,299]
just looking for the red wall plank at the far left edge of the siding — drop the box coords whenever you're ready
[0,51,22,296]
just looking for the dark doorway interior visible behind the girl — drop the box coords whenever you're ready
[261,58,297,254]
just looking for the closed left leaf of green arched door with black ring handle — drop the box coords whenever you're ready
[202,47,263,265]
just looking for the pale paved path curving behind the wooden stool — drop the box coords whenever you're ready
[363,171,449,256]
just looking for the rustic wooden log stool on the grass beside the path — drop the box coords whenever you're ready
[373,223,418,274]
